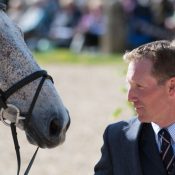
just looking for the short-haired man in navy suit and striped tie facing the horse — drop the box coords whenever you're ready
[95,41,175,175]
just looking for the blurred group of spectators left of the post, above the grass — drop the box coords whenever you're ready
[8,0,104,51]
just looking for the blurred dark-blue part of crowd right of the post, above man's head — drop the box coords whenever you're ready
[121,0,175,48]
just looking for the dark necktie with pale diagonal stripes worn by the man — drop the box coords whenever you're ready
[159,129,175,174]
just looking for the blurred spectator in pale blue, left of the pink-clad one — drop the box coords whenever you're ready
[49,0,81,47]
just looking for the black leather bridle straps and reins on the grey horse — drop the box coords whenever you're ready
[0,70,53,175]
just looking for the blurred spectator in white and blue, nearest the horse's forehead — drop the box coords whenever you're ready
[9,0,59,50]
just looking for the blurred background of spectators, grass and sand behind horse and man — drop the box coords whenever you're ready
[0,0,175,175]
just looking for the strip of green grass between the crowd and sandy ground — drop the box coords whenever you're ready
[33,49,123,64]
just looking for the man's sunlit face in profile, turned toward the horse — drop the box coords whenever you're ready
[127,59,169,124]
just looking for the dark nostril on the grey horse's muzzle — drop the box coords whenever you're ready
[49,119,61,137]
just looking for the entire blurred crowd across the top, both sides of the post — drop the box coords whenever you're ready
[6,0,175,52]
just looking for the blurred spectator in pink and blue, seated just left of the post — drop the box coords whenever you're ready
[72,1,105,51]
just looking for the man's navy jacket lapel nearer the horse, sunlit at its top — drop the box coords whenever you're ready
[122,119,142,175]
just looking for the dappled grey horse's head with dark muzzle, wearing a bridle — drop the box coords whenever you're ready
[0,5,70,148]
